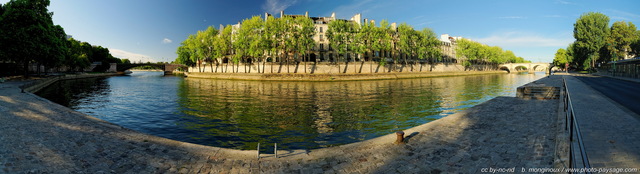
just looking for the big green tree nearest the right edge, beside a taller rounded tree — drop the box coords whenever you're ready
[605,21,637,62]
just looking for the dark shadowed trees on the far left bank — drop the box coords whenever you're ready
[0,0,122,76]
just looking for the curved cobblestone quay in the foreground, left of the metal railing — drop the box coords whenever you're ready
[0,76,560,173]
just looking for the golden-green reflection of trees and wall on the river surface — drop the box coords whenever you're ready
[174,74,541,149]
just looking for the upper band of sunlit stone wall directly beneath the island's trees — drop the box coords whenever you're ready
[189,62,498,74]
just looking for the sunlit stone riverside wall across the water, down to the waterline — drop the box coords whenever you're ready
[186,62,507,81]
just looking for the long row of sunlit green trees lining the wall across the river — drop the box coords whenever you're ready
[176,16,524,72]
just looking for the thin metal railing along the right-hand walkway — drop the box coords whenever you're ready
[562,78,591,173]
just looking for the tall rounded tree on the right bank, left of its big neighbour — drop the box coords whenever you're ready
[573,12,609,69]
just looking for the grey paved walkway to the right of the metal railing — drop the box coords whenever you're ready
[565,76,640,169]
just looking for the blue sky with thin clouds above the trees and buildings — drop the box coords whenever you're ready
[0,0,640,62]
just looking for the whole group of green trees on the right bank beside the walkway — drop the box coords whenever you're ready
[553,12,640,70]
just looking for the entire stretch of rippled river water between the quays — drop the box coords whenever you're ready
[37,71,545,151]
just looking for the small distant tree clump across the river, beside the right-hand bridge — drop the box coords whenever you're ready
[456,39,530,66]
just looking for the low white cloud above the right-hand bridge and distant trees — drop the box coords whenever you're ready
[471,32,574,48]
